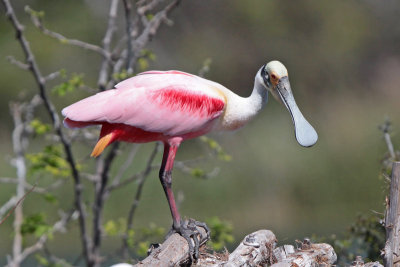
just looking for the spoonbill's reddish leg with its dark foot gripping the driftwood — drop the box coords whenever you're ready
[160,140,210,260]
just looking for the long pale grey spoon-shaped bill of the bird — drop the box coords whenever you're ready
[276,76,318,147]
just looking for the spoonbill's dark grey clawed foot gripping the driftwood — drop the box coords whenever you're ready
[167,219,210,262]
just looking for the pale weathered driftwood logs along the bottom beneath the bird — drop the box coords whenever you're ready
[121,230,383,267]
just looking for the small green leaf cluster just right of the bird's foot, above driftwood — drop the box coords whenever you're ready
[207,216,235,251]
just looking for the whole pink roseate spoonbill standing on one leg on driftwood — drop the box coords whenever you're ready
[62,61,318,256]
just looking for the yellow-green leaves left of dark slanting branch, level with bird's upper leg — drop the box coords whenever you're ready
[26,145,71,177]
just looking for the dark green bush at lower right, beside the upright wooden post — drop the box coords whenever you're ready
[313,215,385,266]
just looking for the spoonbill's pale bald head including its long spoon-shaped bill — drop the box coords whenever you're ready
[258,61,318,147]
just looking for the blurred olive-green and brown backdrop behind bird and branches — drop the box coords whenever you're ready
[0,0,400,264]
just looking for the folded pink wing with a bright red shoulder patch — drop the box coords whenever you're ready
[62,71,225,136]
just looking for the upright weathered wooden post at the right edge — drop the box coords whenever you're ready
[384,162,400,267]
